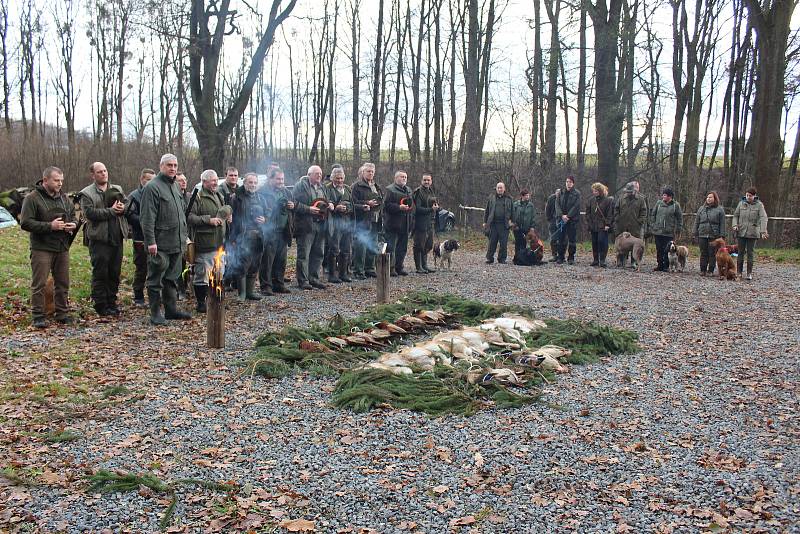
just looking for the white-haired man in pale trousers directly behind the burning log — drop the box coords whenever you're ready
[186,169,227,313]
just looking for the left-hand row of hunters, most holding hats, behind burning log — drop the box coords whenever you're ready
[20,154,439,328]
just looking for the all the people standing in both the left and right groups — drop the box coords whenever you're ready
[20,154,767,328]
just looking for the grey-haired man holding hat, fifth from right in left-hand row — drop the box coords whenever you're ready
[292,165,334,289]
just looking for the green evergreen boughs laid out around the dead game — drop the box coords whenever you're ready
[242,291,639,417]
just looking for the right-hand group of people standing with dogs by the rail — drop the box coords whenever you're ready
[483,176,768,280]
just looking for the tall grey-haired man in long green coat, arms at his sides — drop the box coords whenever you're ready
[139,154,191,325]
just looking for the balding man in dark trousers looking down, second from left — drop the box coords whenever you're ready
[80,161,128,317]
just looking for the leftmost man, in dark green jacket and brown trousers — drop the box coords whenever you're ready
[20,167,76,328]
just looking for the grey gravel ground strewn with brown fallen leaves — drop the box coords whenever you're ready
[0,249,800,532]
